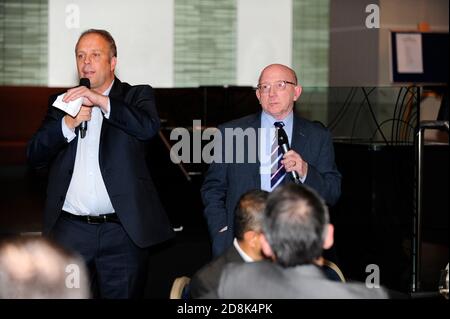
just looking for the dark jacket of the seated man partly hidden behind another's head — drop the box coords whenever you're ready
[190,245,244,298]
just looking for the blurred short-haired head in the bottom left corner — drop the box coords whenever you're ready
[0,237,90,299]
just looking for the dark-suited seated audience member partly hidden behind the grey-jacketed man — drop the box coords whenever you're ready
[190,190,268,298]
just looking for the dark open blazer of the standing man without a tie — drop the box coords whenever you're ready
[27,78,173,247]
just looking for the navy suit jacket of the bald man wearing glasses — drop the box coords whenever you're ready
[201,112,341,256]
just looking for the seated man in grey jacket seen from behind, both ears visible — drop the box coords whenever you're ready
[213,183,388,299]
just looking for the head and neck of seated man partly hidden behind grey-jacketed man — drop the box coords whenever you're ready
[234,189,269,260]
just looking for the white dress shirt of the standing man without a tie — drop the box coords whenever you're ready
[62,81,115,216]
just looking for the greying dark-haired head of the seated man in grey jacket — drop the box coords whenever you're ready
[261,183,333,267]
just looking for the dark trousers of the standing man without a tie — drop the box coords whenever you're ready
[50,216,148,298]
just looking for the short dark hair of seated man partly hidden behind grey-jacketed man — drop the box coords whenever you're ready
[234,189,269,240]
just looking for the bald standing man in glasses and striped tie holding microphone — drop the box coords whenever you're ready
[201,64,341,256]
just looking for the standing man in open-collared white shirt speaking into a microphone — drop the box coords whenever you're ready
[27,29,172,298]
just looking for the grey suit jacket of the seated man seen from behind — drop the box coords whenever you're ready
[214,261,389,299]
